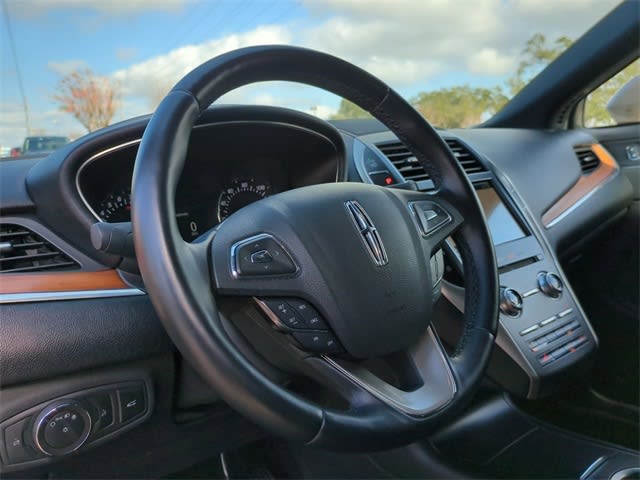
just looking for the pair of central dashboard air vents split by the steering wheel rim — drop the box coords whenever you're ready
[376,138,487,182]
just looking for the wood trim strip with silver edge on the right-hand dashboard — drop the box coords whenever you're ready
[542,144,619,228]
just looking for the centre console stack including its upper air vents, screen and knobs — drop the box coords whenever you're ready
[353,134,597,398]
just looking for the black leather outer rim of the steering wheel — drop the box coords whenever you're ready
[132,46,499,449]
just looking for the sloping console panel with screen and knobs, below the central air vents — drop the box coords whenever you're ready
[458,177,597,398]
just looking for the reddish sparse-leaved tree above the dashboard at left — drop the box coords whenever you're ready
[53,68,121,132]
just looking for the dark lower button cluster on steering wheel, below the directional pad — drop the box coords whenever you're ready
[259,298,343,353]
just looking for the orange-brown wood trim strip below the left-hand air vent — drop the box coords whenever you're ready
[0,270,131,295]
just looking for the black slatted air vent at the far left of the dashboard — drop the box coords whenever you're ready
[0,223,78,273]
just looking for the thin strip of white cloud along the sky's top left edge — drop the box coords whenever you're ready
[6,0,191,18]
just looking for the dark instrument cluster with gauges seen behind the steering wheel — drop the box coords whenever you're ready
[76,122,337,241]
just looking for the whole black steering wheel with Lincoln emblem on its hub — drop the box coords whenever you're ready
[132,46,498,450]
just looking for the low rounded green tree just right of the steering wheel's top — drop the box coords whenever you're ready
[411,85,507,128]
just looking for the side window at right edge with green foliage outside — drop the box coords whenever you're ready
[583,59,640,128]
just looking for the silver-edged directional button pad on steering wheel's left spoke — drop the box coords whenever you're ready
[231,233,298,276]
